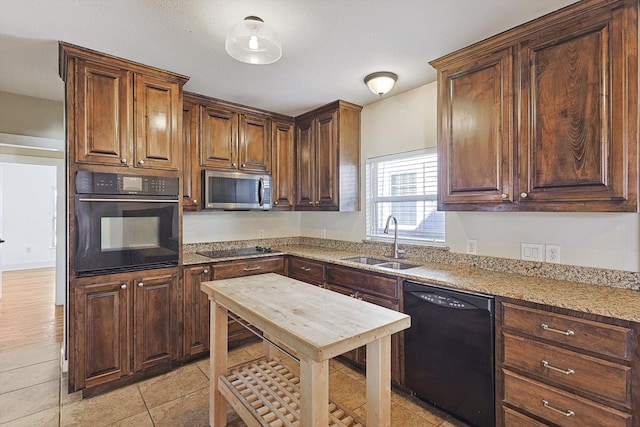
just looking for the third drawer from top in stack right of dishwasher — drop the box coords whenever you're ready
[503,370,631,427]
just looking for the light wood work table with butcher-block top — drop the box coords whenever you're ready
[201,273,410,427]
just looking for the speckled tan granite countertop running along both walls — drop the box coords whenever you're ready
[183,245,640,322]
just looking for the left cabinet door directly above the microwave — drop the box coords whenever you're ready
[200,107,238,170]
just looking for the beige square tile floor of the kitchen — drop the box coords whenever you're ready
[0,344,465,427]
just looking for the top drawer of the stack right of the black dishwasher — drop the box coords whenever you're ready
[502,303,632,360]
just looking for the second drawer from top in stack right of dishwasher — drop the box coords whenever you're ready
[503,334,631,407]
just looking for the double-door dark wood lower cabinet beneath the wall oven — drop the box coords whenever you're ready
[69,268,178,391]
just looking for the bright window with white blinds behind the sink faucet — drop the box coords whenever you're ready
[366,149,444,244]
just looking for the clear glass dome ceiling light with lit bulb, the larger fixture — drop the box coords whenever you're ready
[224,16,282,64]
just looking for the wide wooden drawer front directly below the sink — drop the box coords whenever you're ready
[327,265,399,299]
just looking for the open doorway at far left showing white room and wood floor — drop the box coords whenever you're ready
[0,147,66,352]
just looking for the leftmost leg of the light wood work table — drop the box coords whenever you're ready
[209,298,228,427]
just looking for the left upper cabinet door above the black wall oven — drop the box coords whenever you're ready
[70,60,133,166]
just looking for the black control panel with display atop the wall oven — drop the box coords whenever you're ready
[76,171,180,197]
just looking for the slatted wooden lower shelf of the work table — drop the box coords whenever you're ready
[218,359,364,427]
